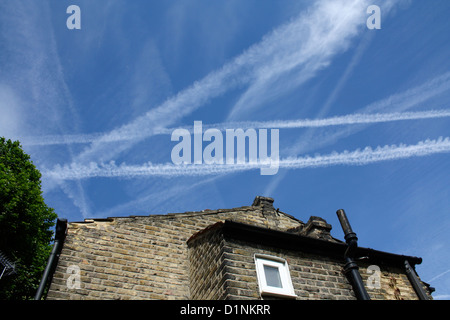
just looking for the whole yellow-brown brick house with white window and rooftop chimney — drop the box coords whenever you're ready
[46,197,432,300]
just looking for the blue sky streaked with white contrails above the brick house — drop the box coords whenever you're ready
[0,0,450,299]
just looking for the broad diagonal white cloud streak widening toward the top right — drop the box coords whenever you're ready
[57,0,366,163]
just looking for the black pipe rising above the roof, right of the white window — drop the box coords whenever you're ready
[336,209,370,300]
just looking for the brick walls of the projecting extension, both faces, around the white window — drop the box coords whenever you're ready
[188,220,426,300]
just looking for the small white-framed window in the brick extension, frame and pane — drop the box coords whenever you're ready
[255,254,296,298]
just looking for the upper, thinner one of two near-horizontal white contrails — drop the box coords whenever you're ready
[22,110,450,145]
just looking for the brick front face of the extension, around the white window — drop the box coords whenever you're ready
[225,241,424,300]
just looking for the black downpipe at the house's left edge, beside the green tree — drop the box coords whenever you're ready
[34,218,67,300]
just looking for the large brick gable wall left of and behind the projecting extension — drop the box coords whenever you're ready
[47,197,303,300]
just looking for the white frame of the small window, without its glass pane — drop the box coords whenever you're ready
[254,253,297,298]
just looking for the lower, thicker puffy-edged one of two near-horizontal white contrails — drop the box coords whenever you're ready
[43,137,450,180]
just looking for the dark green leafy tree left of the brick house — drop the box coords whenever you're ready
[0,138,57,300]
